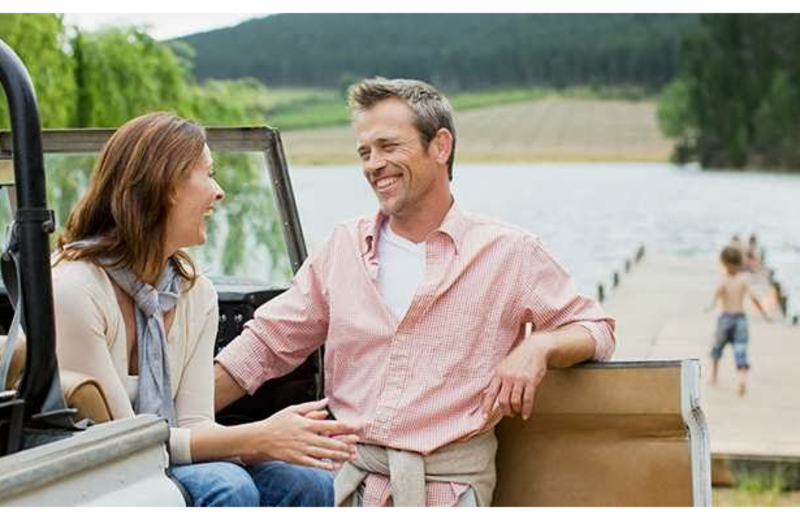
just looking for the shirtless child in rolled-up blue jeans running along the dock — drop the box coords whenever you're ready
[708,246,772,396]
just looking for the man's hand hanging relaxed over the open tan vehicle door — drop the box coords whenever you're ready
[482,335,550,421]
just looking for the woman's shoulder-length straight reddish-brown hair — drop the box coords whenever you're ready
[58,113,206,287]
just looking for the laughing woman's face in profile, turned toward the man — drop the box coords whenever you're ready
[167,145,225,256]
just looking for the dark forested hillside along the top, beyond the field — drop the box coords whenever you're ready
[183,11,697,90]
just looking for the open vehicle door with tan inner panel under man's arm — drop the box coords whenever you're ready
[493,361,711,508]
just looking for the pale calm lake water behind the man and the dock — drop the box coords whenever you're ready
[291,164,800,312]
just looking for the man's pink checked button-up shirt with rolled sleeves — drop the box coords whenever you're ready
[217,205,615,507]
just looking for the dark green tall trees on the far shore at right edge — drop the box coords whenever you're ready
[660,11,800,169]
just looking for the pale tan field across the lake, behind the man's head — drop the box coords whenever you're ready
[276,95,672,164]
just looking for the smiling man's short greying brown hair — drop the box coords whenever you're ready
[348,78,456,181]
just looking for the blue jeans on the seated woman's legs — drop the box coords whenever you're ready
[171,462,333,509]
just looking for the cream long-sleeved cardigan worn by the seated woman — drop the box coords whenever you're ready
[53,261,218,464]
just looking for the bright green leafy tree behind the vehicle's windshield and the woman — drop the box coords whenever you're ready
[0,11,290,279]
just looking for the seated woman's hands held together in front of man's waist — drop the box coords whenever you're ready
[236,400,359,471]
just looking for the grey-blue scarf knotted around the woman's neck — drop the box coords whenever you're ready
[105,262,182,427]
